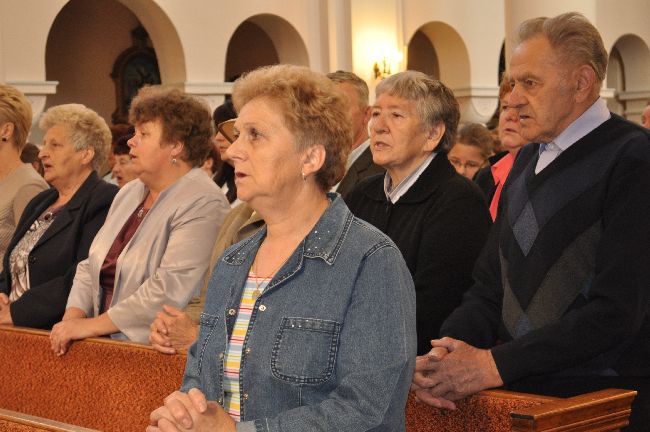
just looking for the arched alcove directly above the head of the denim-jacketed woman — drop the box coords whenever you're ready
[225,14,309,78]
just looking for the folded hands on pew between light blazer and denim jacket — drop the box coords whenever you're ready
[149,305,198,354]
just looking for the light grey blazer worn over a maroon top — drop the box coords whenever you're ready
[66,168,230,343]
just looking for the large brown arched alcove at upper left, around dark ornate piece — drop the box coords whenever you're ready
[45,0,185,124]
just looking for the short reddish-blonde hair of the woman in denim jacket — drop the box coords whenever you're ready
[232,65,352,191]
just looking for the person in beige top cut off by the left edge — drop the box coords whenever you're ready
[0,84,49,272]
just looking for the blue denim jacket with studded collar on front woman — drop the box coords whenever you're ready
[182,195,416,432]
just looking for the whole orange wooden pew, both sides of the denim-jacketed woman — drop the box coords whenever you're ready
[0,326,636,432]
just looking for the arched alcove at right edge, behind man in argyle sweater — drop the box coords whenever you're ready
[607,34,650,121]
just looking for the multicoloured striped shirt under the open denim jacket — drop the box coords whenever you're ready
[223,271,271,421]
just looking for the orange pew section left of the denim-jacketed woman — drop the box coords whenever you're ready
[0,327,185,431]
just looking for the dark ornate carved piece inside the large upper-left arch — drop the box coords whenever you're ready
[111,26,160,124]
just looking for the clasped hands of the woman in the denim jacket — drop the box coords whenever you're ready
[147,388,235,432]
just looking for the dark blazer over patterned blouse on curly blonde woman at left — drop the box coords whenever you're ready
[0,172,118,329]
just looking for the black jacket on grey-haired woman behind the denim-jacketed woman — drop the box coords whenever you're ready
[345,153,492,354]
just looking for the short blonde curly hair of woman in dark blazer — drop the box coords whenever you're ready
[38,104,111,171]
